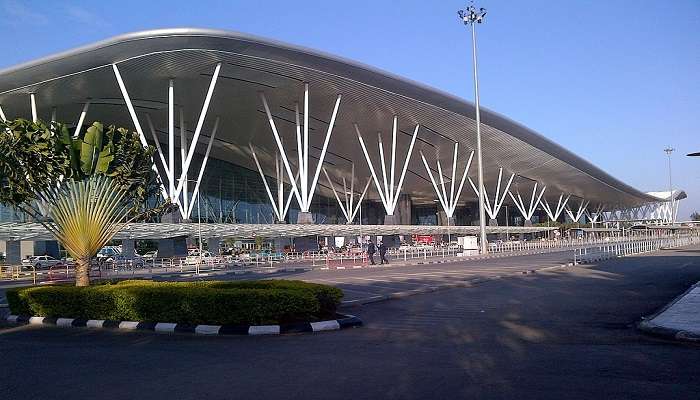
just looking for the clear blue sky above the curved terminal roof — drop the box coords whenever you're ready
[0,0,700,218]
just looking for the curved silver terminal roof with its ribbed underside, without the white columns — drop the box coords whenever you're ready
[0,28,657,207]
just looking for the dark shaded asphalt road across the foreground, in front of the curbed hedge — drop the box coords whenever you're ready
[0,248,700,399]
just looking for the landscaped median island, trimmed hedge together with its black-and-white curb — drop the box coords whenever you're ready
[6,280,361,334]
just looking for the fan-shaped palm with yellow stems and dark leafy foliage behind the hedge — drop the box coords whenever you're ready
[0,119,171,286]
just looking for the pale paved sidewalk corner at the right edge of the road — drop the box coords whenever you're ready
[639,282,700,342]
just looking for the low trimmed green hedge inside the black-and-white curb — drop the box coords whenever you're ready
[7,280,343,325]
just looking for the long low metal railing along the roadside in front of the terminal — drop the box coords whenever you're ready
[0,231,700,284]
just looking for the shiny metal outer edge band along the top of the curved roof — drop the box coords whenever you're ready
[0,28,656,204]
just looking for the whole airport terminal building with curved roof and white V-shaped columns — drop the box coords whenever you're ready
[0,29,685,260]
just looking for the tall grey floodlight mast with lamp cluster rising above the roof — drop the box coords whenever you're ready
[457,4,488,254]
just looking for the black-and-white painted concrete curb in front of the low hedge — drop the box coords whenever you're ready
[2,314,362,336]
